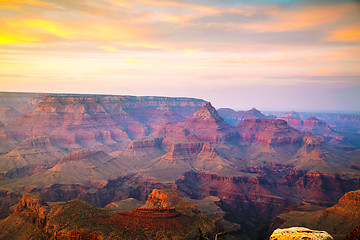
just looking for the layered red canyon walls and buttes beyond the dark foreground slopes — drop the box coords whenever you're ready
[0,93,360,239]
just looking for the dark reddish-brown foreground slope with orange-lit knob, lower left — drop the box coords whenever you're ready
[0,190,216,240]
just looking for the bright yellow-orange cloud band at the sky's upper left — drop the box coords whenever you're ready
[0,16,148,45]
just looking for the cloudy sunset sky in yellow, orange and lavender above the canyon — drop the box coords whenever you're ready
[0,0,360,111]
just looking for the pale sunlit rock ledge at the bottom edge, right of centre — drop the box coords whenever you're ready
[270,227,333,240]
